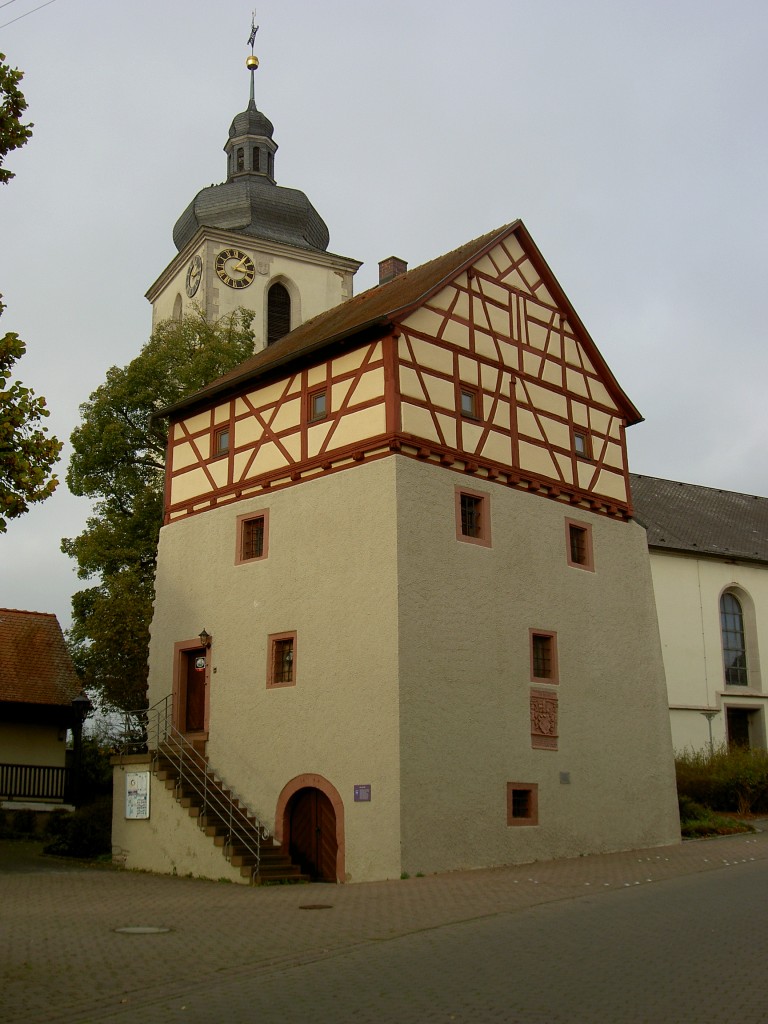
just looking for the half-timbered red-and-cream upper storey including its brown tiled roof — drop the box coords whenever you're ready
[167,221,640,521]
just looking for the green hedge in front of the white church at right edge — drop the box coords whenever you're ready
[675,745,768,814]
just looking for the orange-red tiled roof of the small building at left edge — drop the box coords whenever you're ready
[0,608,83,705]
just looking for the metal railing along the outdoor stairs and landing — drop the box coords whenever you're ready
[118,694,270,882]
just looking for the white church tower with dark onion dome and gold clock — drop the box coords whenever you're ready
[146,30,360,352]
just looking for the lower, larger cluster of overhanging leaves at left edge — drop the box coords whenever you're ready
[0,302,61,534]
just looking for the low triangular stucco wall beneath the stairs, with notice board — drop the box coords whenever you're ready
[112,758,243,885]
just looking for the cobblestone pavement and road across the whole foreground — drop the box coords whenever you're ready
[0,831,768,1024]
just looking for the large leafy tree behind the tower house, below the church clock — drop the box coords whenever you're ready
[61,309,253,711]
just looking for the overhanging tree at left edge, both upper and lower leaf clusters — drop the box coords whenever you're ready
[0,53,61,534]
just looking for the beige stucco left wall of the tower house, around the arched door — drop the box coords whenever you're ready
[150,459,400,880]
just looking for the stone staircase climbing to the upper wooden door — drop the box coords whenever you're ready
[153,733,310,885]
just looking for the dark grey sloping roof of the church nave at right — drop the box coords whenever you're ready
[630,473,768,562]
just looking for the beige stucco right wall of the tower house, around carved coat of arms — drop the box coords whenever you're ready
[397,459,679,873]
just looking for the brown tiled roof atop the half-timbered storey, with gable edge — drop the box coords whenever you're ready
[162,220,642,423]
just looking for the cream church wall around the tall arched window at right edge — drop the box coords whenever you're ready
[650,549,768,750]
